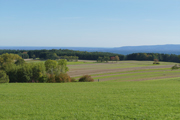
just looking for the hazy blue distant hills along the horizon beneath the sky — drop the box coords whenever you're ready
[0,44,180,55]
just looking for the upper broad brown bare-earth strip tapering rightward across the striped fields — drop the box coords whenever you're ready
[68,63,172,77]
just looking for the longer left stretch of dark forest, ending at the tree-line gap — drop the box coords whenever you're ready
[0,49,125,60]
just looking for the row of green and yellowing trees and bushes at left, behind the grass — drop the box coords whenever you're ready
[0,54,92,83]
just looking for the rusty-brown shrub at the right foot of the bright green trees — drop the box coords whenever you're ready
[55,73,71,83]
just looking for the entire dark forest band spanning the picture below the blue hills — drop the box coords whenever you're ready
[0,49,180,62]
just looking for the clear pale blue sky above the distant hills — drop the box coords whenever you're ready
[0,0,180,48]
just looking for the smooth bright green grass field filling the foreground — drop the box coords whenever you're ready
[0,78,180,120]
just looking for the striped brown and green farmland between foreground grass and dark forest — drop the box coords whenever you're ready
[68,61,180,81]
